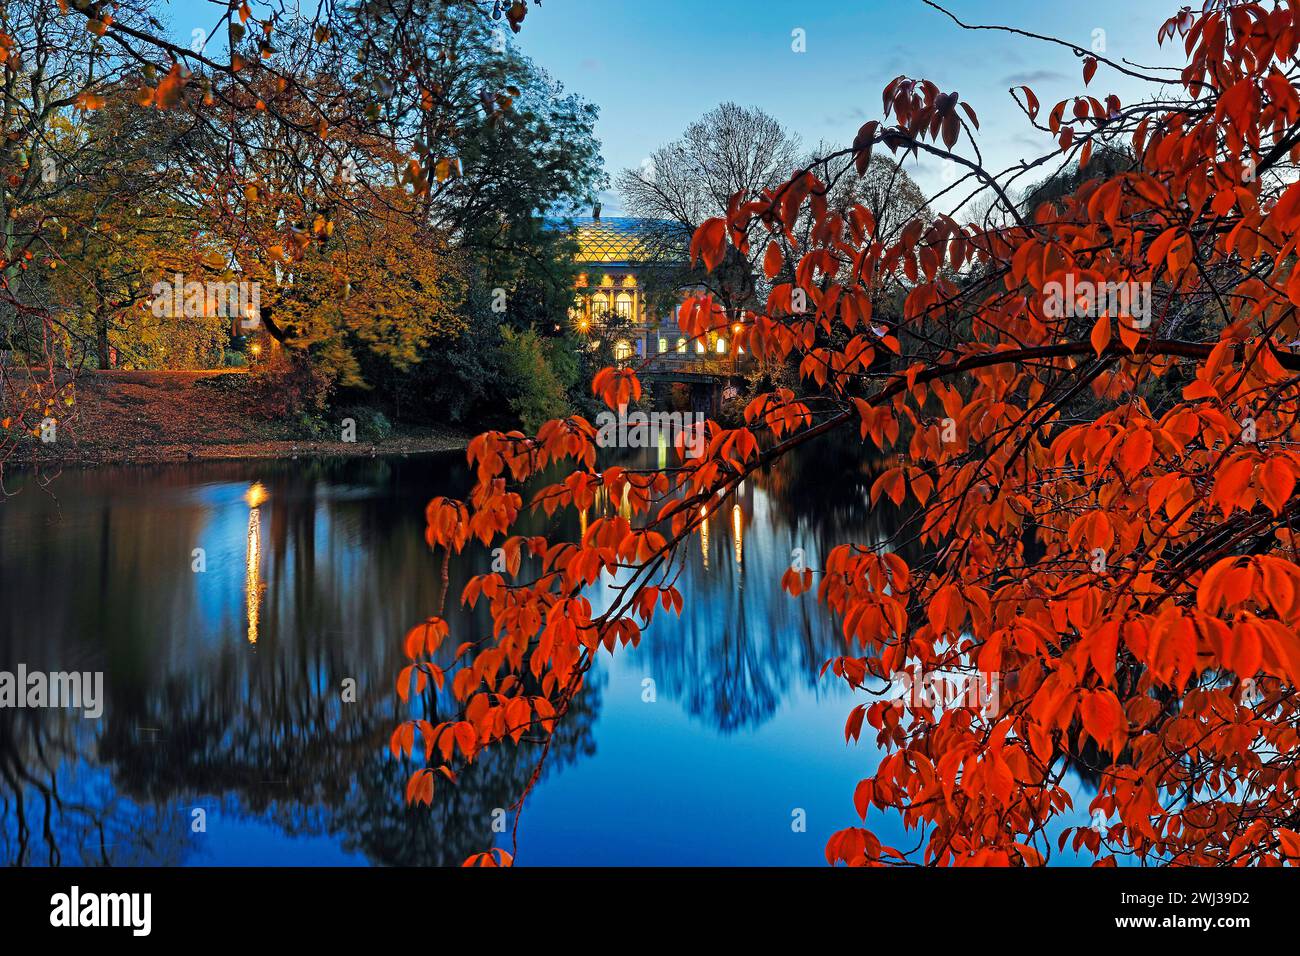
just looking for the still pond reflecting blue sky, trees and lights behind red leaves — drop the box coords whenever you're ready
[0,444,1087,865]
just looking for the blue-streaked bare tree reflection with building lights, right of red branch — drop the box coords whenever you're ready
[605,442,904,732]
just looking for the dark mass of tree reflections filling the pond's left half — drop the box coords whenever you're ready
[0,459,601,865]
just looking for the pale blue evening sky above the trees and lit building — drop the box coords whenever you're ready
[157,0,1182,213]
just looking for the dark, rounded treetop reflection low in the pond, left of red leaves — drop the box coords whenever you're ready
[94,649,599,865]
